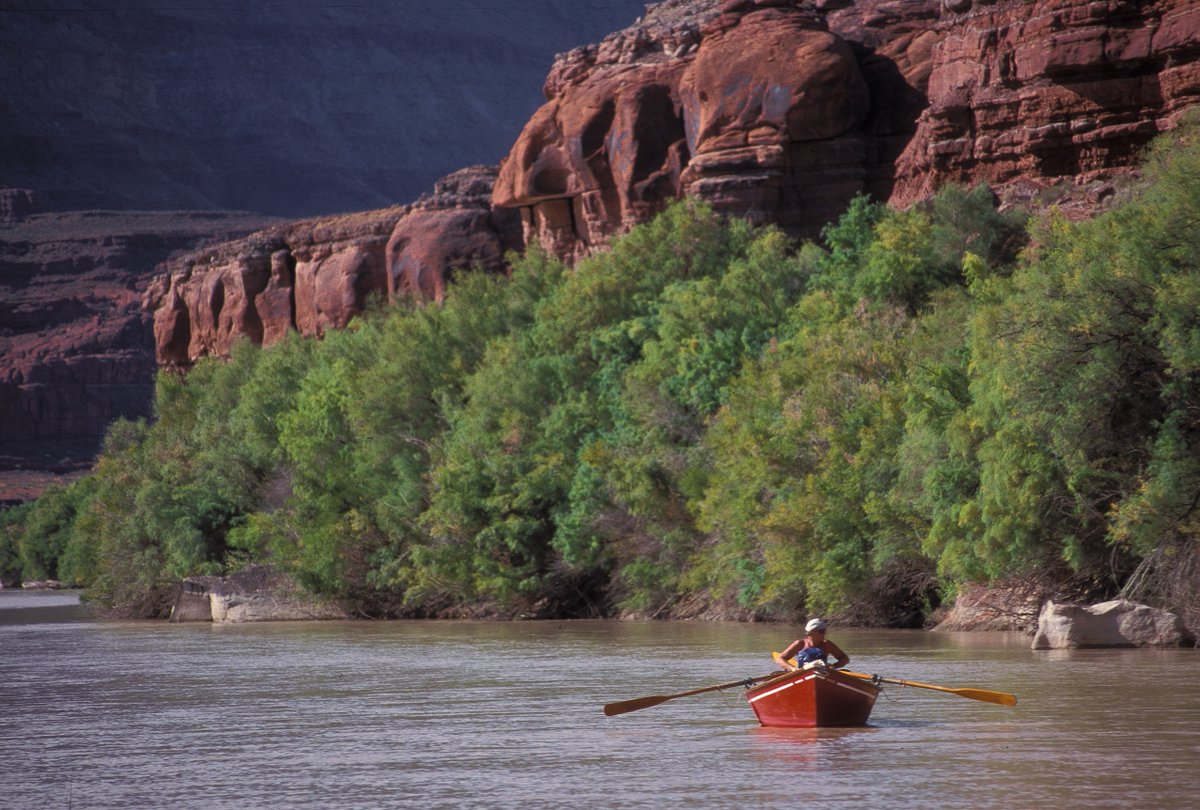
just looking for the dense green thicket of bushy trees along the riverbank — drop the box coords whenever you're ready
[9,126,1200,623]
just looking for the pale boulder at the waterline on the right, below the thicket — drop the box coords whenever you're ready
[1033,599,1188,649]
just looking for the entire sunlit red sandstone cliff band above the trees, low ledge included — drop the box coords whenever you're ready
[145,0,1200,365]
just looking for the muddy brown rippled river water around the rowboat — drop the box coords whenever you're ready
[0,592,1200,810]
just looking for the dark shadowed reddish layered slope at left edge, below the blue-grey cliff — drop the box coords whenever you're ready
[0,212,276,500]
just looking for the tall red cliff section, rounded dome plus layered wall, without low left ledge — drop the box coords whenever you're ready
[493,0,1200,257]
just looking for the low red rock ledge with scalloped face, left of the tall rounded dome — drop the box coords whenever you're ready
[143,167,520,367]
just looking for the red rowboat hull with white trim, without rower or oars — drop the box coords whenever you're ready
[746,666,881,728]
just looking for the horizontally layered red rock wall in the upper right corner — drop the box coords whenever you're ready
[892,0,1200,209]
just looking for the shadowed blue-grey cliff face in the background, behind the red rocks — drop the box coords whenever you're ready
[0,0,643,217]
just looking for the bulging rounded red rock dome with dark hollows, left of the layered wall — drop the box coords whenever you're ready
[493,0,938,257]
